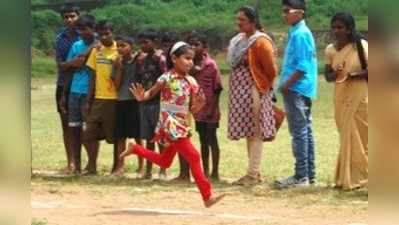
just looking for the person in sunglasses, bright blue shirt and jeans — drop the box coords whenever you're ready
[275,0,317,188]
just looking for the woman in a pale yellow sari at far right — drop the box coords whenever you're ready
[325,13,368,190]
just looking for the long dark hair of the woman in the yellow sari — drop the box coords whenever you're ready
[331,12,367,69]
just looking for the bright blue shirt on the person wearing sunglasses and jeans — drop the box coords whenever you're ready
[279,20,317,99]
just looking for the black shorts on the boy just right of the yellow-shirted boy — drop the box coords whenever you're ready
[115,100,140,139]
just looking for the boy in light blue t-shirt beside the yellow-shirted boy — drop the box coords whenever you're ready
[63,15,98,173]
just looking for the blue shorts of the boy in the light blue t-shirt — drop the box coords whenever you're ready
[68,92,87,127]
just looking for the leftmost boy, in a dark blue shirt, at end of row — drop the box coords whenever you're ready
[55,5,79,172]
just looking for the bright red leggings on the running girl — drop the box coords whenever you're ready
[133,138,212,201]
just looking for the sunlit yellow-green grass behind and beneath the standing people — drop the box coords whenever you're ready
[31,56,368,209]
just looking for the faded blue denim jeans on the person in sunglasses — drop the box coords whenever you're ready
[283,91,316,180]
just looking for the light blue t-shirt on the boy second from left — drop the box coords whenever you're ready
[67,40,91,94]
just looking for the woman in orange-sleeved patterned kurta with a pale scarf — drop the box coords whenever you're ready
[227,6,277,185]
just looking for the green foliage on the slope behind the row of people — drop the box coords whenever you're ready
[32,0,368,51]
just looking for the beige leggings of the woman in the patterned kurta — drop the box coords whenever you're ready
[247,85,263,178]
